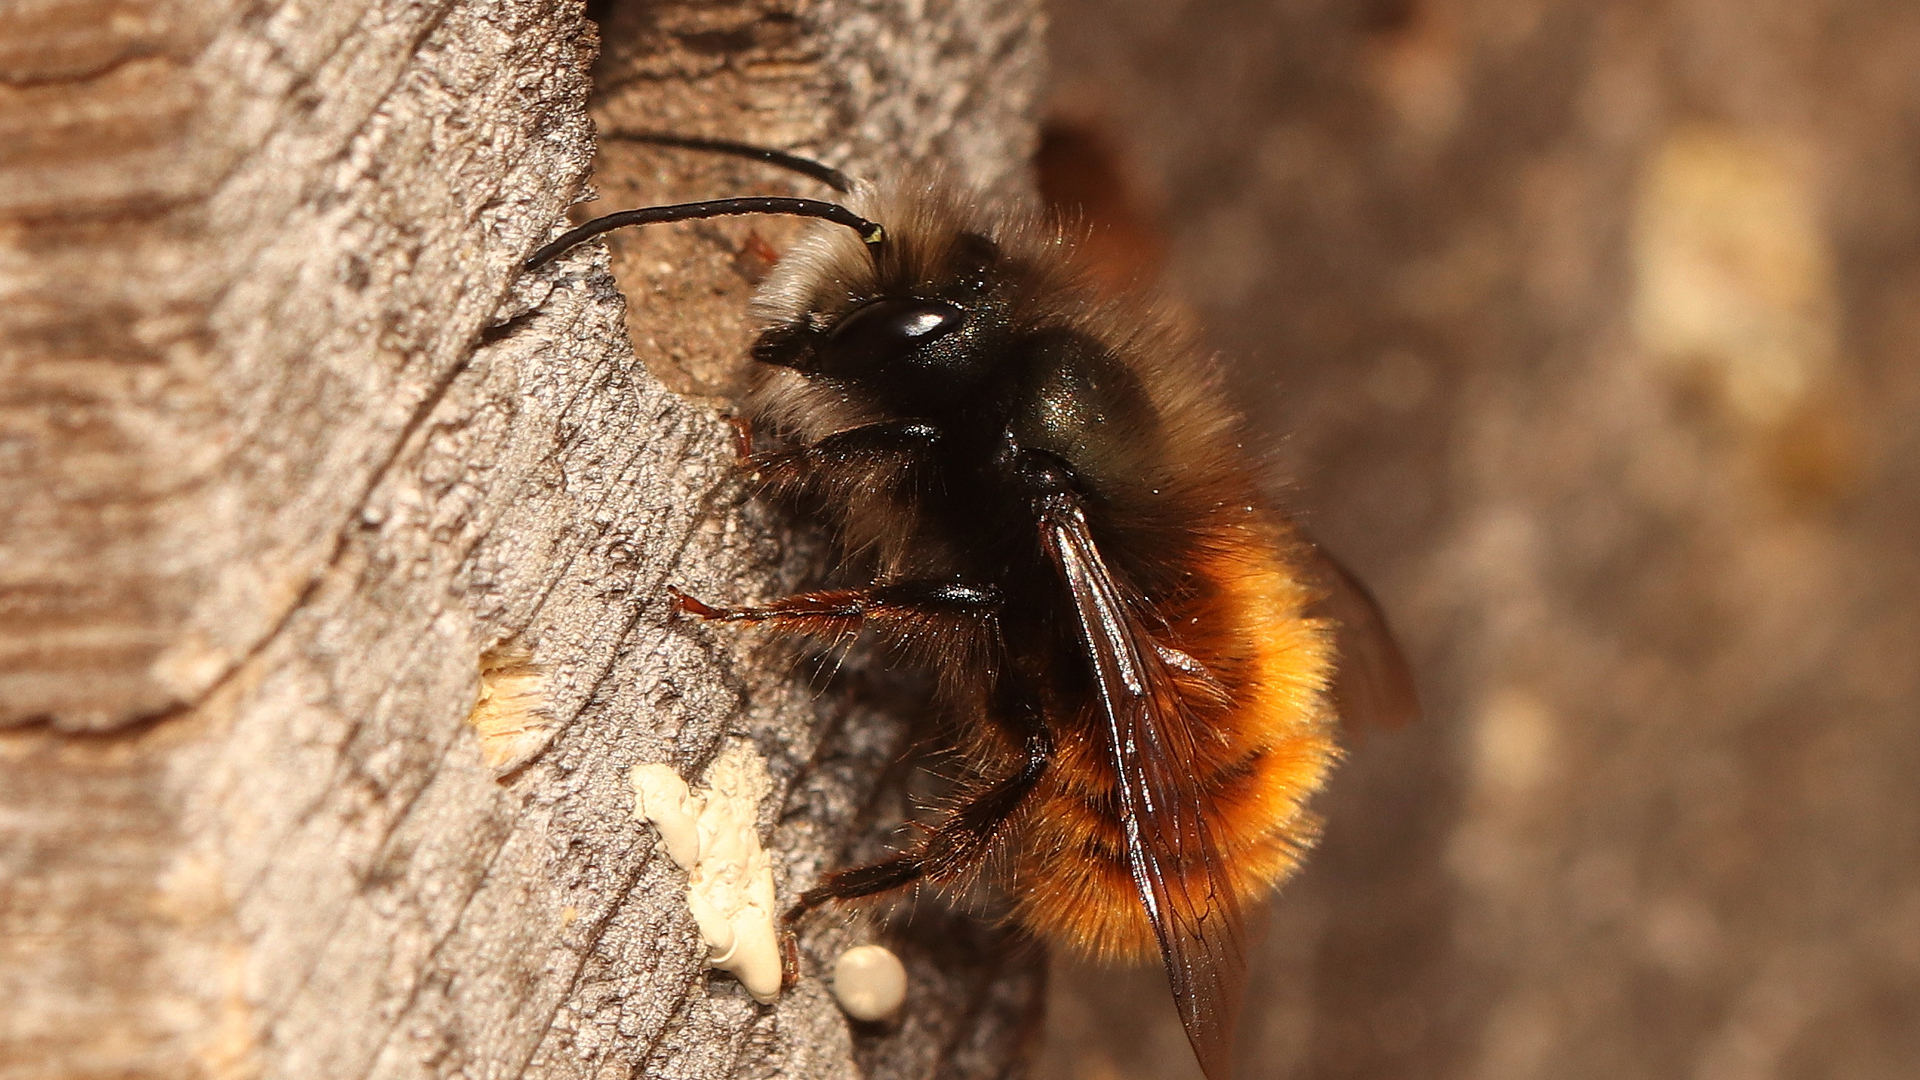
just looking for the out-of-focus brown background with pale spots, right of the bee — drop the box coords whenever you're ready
[1039,0,1920,1080]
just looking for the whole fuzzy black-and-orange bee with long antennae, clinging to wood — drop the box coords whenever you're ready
[528,136,1413,1080]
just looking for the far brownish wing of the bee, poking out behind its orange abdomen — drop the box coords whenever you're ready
[1306,540,1421,728]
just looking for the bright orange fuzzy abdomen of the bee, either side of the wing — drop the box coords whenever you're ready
[1014,544,1338,959]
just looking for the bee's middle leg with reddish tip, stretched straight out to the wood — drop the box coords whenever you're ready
[668,580,1000,636]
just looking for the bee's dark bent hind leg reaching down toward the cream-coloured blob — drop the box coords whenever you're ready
[785,707,1054,922]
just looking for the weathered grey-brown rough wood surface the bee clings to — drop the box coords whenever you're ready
[0,0,1039,1078]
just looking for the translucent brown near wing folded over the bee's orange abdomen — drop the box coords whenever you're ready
[1041,495,1246,1080]
